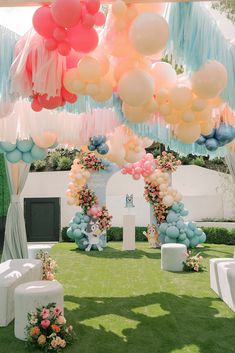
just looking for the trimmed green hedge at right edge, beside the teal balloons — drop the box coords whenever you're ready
[202,227,235,245]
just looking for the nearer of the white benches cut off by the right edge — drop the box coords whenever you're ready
[218,262,235,311]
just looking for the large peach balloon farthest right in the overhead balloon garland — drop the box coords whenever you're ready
[191,61,228,99]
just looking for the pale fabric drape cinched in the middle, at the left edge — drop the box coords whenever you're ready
[2,162,30,262]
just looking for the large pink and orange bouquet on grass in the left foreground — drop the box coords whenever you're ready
[26,303,74,353]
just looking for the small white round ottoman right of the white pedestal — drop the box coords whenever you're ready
[161,243,187,272]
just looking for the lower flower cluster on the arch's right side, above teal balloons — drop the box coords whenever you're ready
[144,181,167,225]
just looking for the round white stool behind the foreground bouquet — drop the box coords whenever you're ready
[15,281,64,341]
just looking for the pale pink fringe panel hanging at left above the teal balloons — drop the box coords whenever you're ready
[0,100,120,146]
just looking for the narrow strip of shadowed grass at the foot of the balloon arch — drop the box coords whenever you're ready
[70,246,161,260]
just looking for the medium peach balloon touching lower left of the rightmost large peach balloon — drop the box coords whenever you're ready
[169,86,193,110]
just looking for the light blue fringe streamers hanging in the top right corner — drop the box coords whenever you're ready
[168,2,235,109]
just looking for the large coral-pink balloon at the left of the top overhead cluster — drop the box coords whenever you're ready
[33,6,57,38]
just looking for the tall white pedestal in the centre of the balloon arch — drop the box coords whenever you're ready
[122,214,135,250]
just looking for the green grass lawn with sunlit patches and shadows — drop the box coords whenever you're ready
[0,243,235,353]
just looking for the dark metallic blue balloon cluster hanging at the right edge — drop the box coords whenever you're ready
[196,123,235,152]
